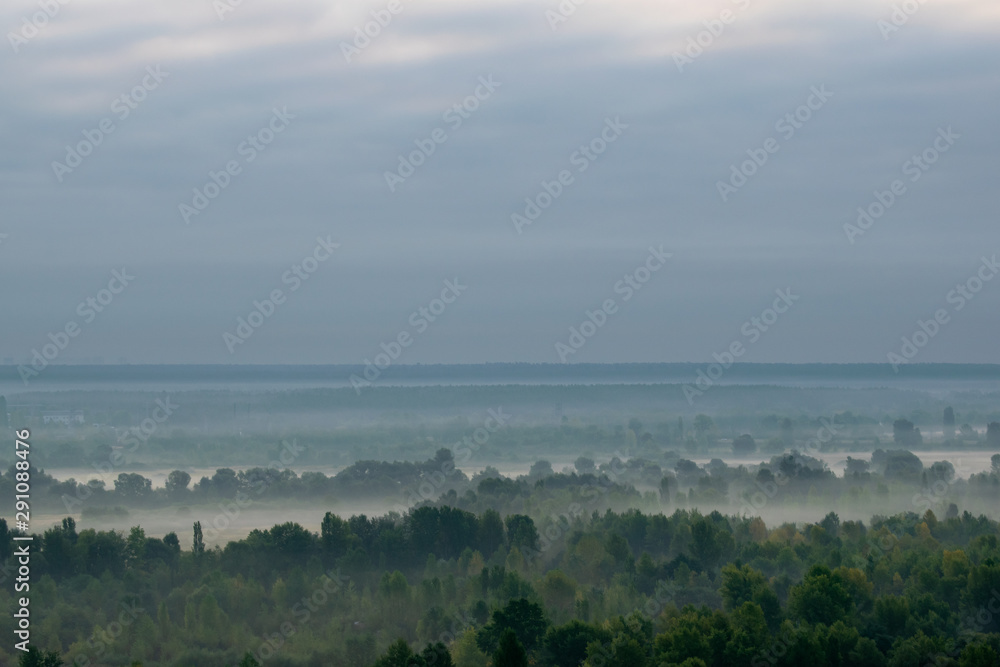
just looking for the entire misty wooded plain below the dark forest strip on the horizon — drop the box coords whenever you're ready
[0,378,1000,667]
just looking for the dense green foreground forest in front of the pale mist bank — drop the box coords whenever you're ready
[0,452,1000,667]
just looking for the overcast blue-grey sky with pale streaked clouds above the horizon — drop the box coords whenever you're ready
[0,0,1000,366]
